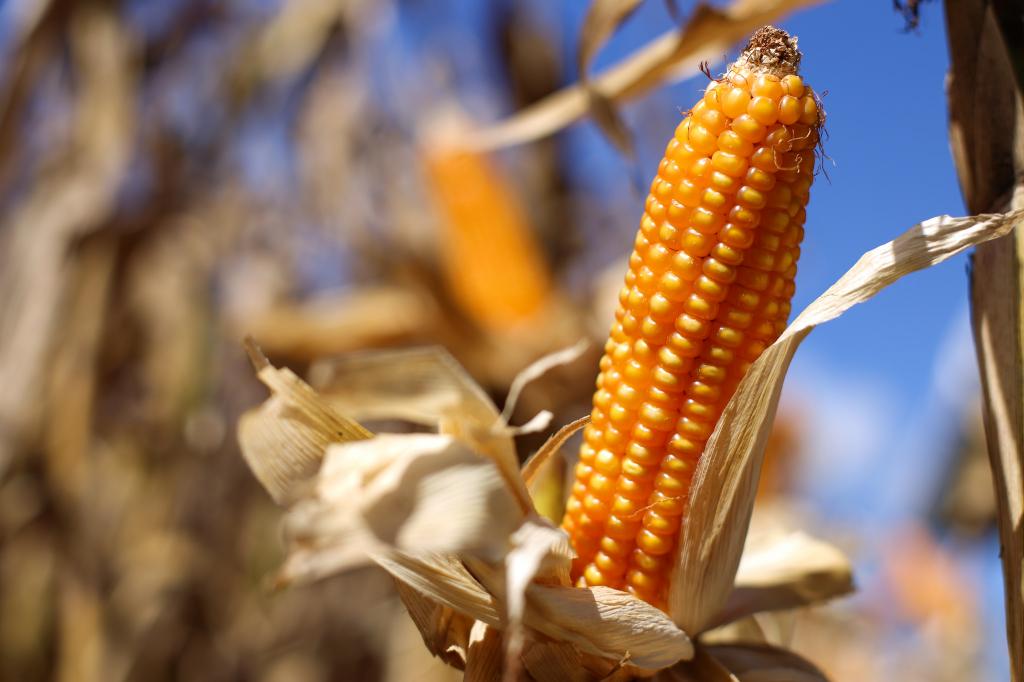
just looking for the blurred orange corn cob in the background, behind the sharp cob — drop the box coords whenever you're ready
[425,146,551,333]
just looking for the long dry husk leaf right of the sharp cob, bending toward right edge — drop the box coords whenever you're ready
[669,211,1024,632]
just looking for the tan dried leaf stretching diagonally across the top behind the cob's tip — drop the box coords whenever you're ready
[463,0,821,150]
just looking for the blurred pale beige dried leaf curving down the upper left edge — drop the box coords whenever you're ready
[0,5,137,475]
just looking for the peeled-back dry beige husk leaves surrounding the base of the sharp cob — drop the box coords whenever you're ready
[240,193,1024,680]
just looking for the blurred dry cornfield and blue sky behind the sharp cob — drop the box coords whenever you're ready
[0,0,1024,682]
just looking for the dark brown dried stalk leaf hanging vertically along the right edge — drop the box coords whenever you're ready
[944,0,1024,682]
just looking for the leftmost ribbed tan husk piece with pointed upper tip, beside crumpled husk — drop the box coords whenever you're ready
[238,344,372,504]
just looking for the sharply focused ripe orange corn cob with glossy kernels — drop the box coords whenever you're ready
[562,27,823,608]
